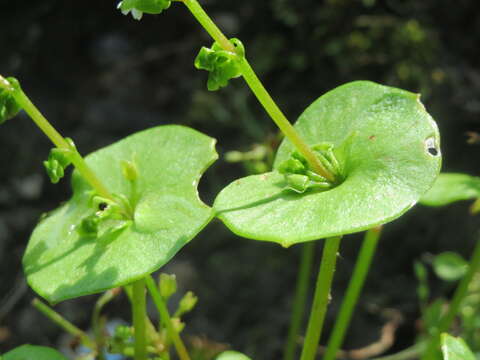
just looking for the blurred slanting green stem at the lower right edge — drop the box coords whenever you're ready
[421,241,480,360]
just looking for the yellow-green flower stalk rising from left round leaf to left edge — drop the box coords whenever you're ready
[6,77,113,200]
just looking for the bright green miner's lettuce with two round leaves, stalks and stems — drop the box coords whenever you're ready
[0,0,473,360]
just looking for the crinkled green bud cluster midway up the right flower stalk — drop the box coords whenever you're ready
[194,38,245,91]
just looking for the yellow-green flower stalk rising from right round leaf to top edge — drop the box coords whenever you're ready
[180,0,335,182]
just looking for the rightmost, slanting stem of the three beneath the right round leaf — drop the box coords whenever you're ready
[323,227,381,360]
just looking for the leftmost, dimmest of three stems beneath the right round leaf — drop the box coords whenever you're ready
[283,241,315,360]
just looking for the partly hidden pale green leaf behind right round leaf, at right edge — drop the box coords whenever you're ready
[420,173,480,206]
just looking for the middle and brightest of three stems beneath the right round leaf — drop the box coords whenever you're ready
[300,236,342,360]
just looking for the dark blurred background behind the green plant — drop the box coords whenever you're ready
[0,0,480,359]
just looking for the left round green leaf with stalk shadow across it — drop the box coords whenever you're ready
[23,125,217,303]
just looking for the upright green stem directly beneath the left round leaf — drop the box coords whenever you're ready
[132,279,147,360]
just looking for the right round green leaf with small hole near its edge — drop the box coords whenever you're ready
[214,81,441,246]
